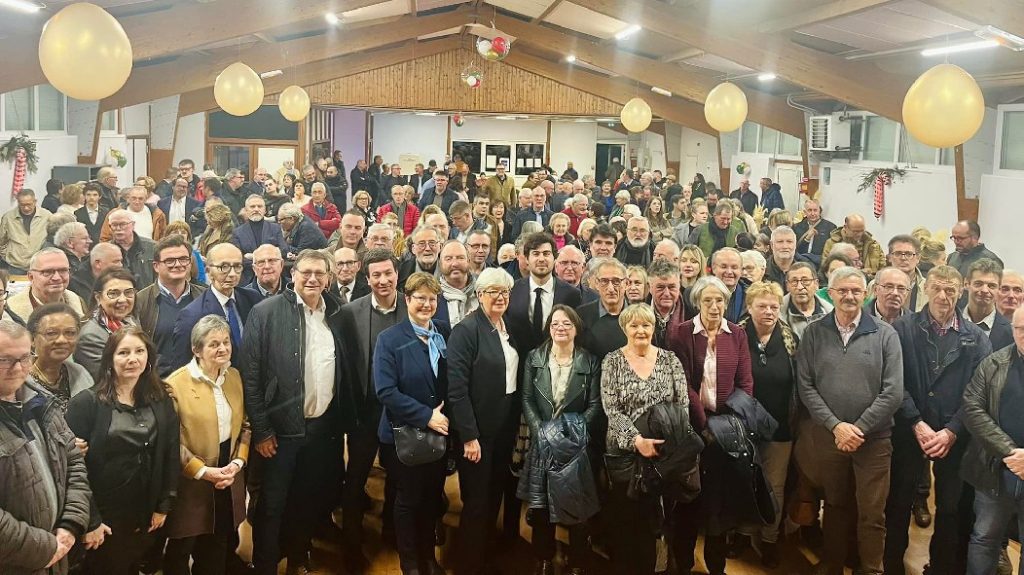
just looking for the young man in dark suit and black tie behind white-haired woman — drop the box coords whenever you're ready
[505,233,583,360]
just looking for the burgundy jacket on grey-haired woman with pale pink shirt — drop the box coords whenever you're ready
[666,317,754,430]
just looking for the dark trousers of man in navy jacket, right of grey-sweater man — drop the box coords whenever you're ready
[885,426,974,575]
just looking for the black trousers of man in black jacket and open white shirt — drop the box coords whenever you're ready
[253,411,344,575]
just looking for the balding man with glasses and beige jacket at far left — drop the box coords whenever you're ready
[7,248,85,321]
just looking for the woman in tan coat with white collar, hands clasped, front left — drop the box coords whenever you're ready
[164,315,250,575]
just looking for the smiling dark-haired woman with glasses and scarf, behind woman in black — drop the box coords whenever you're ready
[75,268,138,380]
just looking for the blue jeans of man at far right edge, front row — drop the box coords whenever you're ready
[967,470,1024,575]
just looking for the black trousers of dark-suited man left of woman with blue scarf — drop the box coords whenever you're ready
[341,426,394,548]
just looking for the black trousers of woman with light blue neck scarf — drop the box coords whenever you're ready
[381,443,446,573]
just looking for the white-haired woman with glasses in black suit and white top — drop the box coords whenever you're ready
[447,268,520,575]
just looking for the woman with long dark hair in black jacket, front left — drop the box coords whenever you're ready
[66,326,181,575]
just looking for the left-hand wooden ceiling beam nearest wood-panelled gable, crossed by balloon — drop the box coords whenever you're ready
[178,37,459,117]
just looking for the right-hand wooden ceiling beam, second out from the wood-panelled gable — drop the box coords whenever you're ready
[495,15,806,139]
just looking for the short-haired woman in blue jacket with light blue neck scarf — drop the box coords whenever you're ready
[373,271,451,575]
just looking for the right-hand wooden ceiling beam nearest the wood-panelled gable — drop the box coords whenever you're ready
[502,49,718,136]
